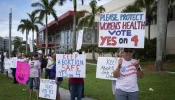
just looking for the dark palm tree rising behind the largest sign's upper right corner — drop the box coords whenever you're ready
[134,0,157,40]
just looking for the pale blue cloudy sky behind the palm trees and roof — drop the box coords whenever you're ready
[0,0,111,40]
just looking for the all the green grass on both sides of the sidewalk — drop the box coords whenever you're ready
[0,65,175,100]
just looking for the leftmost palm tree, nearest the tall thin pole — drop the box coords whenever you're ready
[17,19,31,54]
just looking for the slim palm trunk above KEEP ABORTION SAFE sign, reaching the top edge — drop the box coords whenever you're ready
[72,0,77,52]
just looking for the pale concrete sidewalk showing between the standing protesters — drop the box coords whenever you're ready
[1,70,95,100]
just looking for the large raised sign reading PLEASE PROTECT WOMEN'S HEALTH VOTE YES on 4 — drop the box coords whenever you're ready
[98,12,146,48]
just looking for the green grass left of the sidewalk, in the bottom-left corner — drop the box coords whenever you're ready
[0,73,46,100]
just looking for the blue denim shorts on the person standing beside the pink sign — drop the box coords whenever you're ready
[29,77,39,90]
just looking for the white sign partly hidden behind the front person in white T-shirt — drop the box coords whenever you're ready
[96,57,118,80]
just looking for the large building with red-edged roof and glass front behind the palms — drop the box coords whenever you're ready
[37,0,175,54]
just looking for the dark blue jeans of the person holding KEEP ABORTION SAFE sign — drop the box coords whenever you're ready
[69,82,83,100]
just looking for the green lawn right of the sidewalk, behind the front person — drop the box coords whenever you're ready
[61,65,175,100]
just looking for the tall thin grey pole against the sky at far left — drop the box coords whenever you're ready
[9,8,12,58]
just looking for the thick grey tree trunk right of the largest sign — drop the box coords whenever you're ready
[156,0,168,71]
